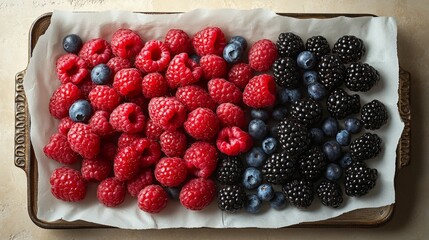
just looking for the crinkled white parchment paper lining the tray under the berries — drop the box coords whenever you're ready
[24,9,403,229]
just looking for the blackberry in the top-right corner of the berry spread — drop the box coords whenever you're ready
[332,35,365,63]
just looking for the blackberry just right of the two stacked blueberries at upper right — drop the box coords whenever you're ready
[317,54,346,91]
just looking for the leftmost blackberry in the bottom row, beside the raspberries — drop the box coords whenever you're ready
[217,185,246,213]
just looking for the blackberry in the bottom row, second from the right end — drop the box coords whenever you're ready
[316,180,343,208]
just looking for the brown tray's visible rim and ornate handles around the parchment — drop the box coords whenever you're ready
[14,13,411,228]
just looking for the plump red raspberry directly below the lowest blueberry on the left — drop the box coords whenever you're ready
[67,123,100,158]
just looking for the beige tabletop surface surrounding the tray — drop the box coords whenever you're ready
[0,0,429,240]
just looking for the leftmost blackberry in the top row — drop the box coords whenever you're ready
[276,32,304,59]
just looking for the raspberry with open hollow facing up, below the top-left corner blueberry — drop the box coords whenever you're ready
[57,53,89,84]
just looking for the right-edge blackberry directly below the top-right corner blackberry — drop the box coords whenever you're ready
[344,63,380,92]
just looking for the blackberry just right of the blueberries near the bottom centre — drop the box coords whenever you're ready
[262,152,297,184]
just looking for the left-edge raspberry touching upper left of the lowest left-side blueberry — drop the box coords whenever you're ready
[49,83,80,119]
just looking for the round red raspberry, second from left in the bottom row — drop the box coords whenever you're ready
[97,177,127,207]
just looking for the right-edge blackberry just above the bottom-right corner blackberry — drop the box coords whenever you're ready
[349,133,382,161]
